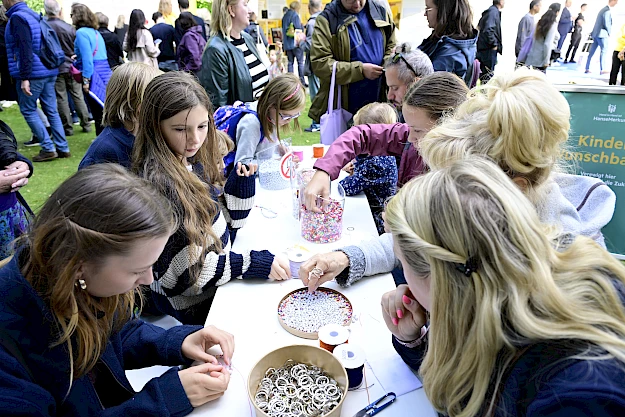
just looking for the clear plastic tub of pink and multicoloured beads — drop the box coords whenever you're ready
[300,182,345,243]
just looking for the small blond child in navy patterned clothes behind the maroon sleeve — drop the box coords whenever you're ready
[341,103,397,234]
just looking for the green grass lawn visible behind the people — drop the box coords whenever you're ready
[0,99,319,212]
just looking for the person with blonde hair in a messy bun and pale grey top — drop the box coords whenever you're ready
[419,68,616,247]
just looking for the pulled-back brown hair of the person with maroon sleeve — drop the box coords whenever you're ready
[404,71,469,120]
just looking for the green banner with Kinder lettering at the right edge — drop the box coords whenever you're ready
[562,87,625,257]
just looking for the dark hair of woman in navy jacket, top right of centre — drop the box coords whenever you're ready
[434,0,473,39]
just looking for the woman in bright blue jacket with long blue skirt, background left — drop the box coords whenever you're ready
[72,3,111,135]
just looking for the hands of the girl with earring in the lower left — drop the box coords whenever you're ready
[178,326,234,408]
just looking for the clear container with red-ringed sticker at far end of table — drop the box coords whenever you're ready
[256,139,293,190]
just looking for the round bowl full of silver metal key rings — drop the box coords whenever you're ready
[247,345,348,417]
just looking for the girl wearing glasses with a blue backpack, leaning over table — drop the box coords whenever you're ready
[215,73,306,174]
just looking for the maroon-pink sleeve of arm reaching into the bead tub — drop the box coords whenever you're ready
[315,123,410,180]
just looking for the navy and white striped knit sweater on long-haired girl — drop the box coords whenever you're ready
[148,165,273,324]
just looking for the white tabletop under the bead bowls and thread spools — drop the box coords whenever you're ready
[128,148,436,417]
